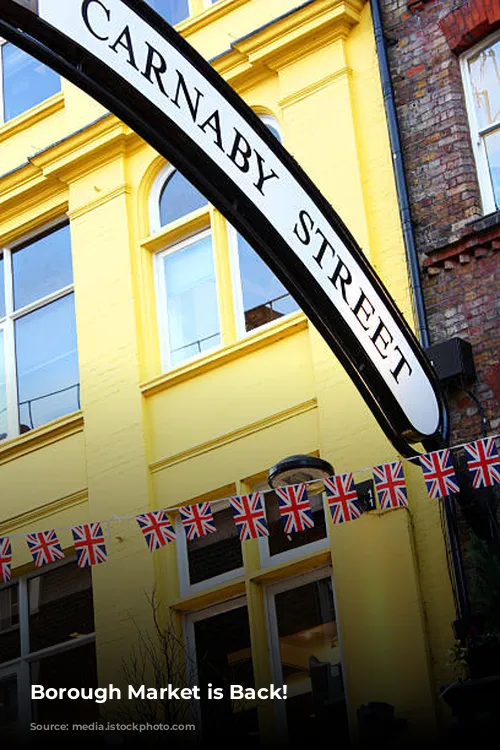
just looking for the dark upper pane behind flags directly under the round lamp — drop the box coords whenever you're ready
[265,492,326,555]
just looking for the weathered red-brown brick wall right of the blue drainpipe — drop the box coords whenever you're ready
[380,0,500,443]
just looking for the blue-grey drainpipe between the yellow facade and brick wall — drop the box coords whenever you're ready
[370,0,430,349]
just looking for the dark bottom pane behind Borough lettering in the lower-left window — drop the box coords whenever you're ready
[31,643,99,748]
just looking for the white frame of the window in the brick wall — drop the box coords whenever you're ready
[460,32,500,215]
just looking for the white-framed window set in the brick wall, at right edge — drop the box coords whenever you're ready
[461,35,500,213]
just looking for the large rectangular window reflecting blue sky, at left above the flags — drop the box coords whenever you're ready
[0,224,80,440]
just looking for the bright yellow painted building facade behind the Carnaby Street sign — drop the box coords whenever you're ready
[0,0,455,744]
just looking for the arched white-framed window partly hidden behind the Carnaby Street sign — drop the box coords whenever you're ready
[150,118,298,368]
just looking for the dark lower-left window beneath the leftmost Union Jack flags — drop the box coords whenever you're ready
[0,561,98,747]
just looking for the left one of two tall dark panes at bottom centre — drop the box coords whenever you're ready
[194,607,259,747]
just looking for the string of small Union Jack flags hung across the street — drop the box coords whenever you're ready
[0,434,500,583]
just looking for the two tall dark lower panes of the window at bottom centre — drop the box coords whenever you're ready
[185,567,349,748]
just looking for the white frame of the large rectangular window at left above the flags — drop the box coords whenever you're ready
[0,217,80,445]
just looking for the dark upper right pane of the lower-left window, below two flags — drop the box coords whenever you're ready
[29,563,94,651]
